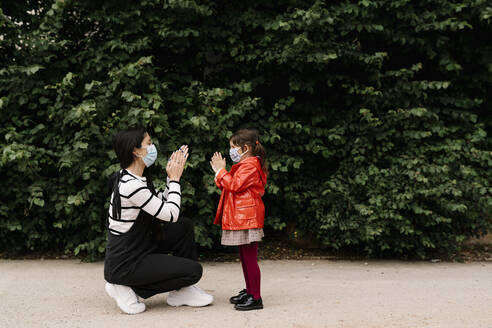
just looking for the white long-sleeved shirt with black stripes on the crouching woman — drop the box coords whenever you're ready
[109,173,181,235]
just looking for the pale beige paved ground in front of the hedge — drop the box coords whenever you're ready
[0,260,492,328]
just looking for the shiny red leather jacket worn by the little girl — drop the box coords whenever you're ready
[214,157,267,230]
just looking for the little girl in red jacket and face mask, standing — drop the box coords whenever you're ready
[210,129,268,311]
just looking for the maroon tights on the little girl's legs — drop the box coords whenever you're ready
[239,242,261,300]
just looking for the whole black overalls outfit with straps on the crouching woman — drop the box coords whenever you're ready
[104,170,203,298]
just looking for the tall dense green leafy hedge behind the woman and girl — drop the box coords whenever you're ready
[0,0,492,259]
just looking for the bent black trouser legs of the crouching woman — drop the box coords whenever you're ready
[127,217,203,298]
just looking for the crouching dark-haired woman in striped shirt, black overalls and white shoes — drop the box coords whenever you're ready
[104,128,213,314]
